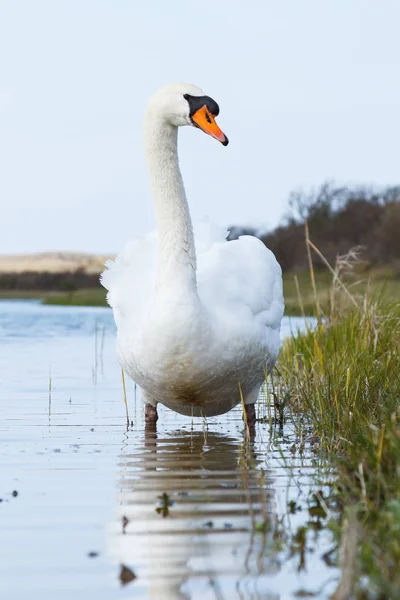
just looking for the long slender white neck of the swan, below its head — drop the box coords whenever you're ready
[145,112,196,291]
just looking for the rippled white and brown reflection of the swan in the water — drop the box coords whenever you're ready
[112,428,278,600]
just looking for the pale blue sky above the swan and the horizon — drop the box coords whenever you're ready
[0,0,400,254]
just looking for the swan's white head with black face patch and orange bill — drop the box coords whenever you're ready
[148,83,229,146]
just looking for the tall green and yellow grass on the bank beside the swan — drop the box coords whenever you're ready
[278,248,400,600]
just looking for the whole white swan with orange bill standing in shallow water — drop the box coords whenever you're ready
[101,84,284,425]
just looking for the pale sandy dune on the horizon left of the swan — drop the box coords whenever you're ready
[0,252,113,274]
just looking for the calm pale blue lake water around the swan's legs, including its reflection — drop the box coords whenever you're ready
[0,301,338,600]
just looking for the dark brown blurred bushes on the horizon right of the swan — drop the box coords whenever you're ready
[228,182,400,271]
